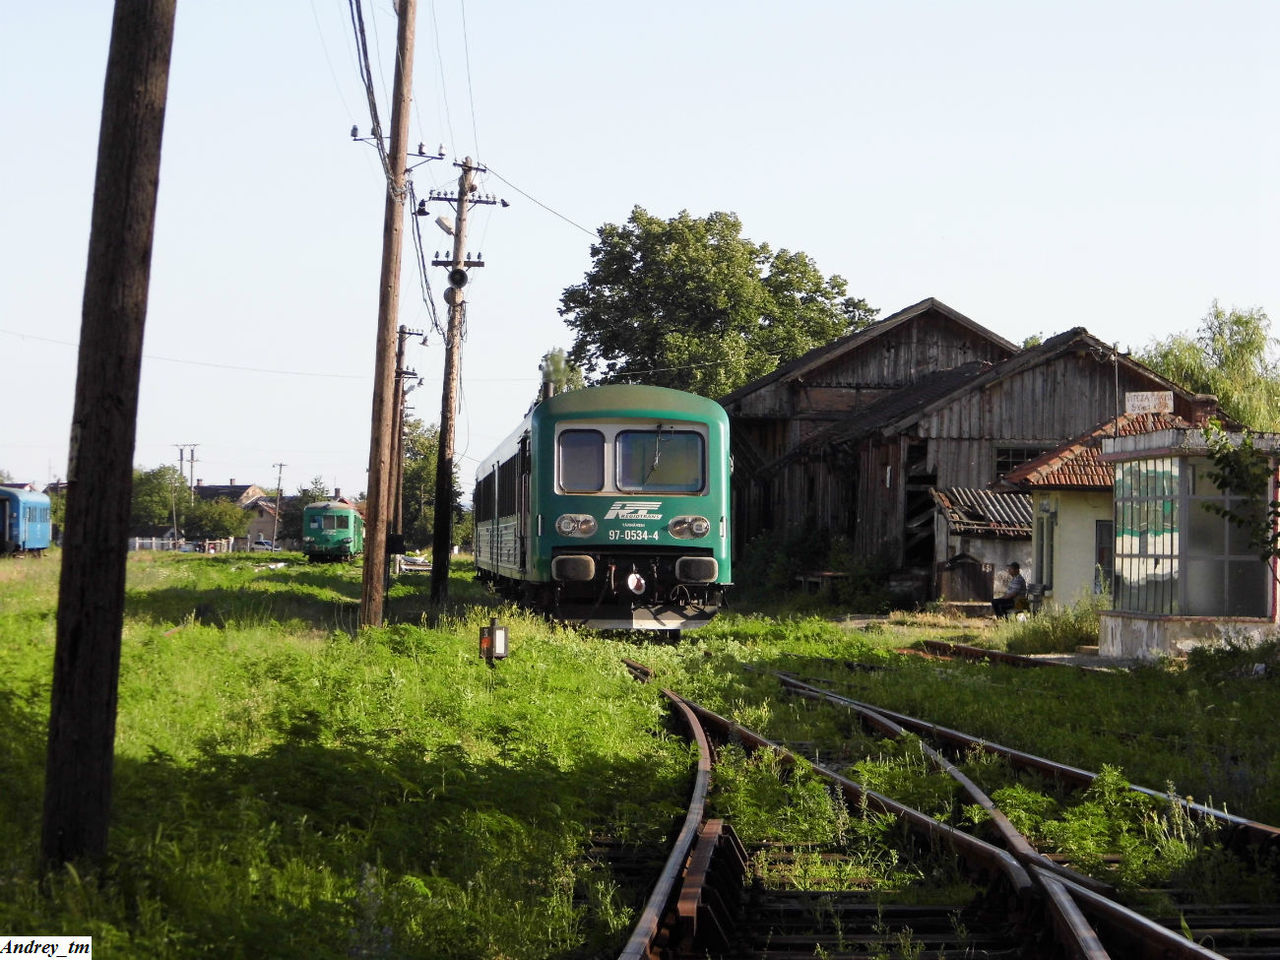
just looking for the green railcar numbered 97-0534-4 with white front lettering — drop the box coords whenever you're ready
[474,385,732,631]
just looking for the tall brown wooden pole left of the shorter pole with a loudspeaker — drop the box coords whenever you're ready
[360,0,417,627]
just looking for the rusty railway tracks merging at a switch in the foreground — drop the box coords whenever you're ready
[621,662,1280,960]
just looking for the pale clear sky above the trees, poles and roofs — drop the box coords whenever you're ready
[0,0,1280,504]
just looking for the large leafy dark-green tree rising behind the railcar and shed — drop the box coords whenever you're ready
[559,206,876,397]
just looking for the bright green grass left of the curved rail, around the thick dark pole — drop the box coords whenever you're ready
[0,558,689,957]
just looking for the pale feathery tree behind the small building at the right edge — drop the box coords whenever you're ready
[1138,300,1280,430]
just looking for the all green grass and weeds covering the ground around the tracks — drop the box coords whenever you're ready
[0,552,1280,957]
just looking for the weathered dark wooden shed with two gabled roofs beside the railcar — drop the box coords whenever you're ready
[721,300,1204,599]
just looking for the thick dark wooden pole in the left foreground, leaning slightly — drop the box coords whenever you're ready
[41,0,177,865]
